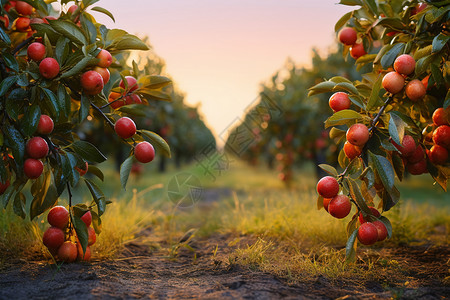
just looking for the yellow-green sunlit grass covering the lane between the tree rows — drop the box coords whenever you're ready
[0,157,450,281]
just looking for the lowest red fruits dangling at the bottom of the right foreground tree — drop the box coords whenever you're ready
[317,176,388,245]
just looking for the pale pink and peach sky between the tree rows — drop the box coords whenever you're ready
[92,0,352,143]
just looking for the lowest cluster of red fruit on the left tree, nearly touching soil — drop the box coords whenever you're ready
[42,206,97,262]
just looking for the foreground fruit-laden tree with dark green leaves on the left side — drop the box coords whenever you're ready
[0,0,171,262]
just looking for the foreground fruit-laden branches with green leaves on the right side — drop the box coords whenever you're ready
[309,0,450,260]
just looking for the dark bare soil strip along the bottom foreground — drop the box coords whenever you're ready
[0,231,450,299]
